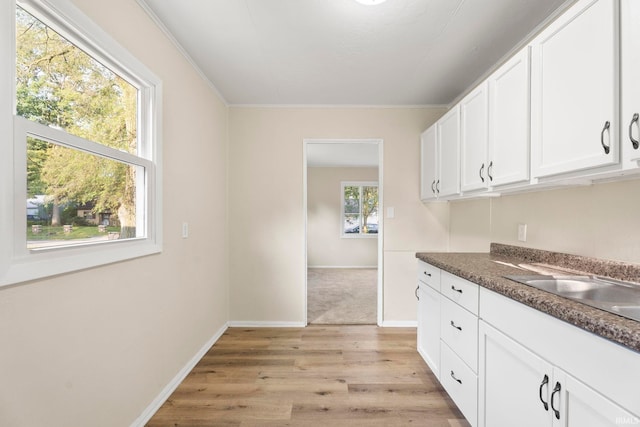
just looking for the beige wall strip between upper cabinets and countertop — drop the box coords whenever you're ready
[451,179,640,264]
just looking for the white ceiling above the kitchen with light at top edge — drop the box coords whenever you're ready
[137,0,566,105]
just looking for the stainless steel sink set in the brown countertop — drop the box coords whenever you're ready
[505,275,640,321]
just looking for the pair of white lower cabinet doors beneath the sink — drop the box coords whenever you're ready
[478,321,634,427]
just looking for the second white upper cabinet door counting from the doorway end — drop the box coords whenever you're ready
[436,105,460,197]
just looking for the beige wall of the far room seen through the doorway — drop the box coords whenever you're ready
[307,167,378,267]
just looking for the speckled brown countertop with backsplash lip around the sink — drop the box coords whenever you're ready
[416,243,640,352]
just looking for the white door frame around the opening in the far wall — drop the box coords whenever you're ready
[302,138,384,326]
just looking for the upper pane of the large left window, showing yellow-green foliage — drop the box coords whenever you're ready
[16,7,138,154]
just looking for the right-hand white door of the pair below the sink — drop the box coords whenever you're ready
[551,368,640,427]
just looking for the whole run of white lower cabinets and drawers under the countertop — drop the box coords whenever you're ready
[417,261,640,427]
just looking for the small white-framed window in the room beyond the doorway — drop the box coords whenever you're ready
[341,182,378,237]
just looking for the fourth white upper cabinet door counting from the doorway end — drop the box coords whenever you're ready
[487,47,531,186]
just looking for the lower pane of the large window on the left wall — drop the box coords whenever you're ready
[26,137,144,249]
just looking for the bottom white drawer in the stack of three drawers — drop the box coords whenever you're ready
[440,342,478,426]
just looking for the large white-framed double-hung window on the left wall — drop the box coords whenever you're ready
[0,0,161,286]
